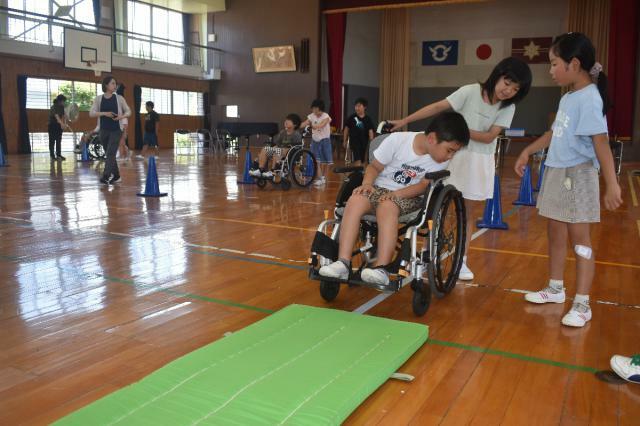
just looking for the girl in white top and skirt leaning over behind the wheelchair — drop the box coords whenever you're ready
[390,57,531,280]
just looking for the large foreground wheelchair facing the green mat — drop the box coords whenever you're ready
[309,134,466,316]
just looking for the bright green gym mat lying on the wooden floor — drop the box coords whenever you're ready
[56,305,428,426]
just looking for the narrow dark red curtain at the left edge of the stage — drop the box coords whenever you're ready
[325,13,347,131]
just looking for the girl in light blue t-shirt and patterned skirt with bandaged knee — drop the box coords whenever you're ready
[515,33,622,327]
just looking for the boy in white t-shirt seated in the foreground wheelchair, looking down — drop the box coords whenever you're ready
[319,112,469,285]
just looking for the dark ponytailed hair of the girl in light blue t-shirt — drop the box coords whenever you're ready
[551,33,611,115]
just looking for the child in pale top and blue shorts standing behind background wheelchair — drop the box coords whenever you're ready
[300,99,333,186]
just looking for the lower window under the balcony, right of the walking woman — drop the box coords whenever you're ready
[140,87,204,116]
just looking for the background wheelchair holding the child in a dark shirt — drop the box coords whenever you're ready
[254,127,318,191]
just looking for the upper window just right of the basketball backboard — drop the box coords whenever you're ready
[127,0,185,64]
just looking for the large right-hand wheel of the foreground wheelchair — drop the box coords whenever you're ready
[427,185,467,298]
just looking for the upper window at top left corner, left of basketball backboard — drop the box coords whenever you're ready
[7,0,95,46]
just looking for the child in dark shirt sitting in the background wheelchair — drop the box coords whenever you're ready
[249,114,302,179]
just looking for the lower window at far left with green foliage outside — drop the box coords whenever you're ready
[27,78,102,111]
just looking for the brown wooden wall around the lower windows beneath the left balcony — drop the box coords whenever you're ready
[0,55,209,154]
